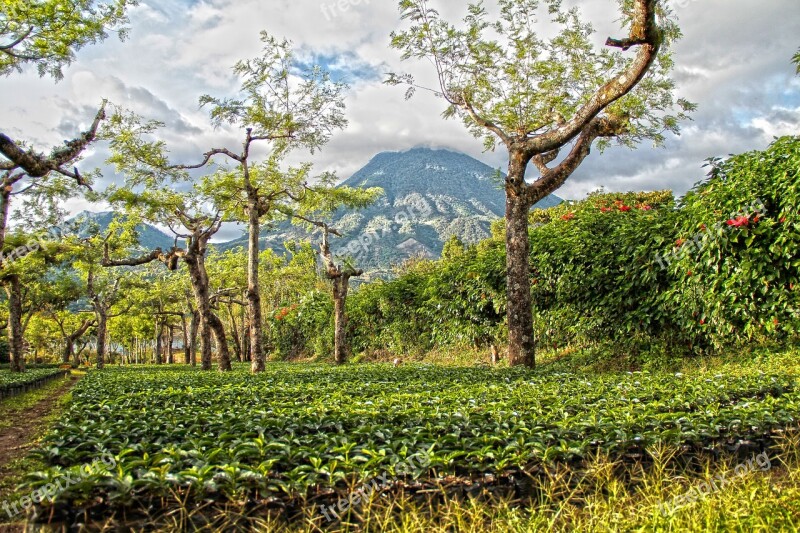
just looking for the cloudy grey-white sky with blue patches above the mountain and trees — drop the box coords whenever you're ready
[0,0,800,240]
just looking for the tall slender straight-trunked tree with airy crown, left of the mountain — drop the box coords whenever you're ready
[169,33,347,372]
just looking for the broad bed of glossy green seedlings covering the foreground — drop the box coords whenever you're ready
[27,356,800,524]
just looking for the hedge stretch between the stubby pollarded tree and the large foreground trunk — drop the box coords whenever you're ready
[350,240,506,354]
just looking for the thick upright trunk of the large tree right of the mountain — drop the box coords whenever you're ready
[506,153,536,368]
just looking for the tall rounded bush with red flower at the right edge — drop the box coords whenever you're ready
[667,137,800,349]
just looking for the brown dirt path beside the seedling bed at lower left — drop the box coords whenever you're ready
[0,376,79,472]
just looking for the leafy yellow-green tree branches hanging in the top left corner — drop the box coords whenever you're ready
[0,0,138,80]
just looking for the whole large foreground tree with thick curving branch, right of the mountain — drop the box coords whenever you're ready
[387,0,694,366]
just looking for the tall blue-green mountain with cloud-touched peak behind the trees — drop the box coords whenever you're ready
[218,148,561,271]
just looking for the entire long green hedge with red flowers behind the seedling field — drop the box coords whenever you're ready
[264,137,800,366]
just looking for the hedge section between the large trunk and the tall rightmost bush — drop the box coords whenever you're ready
[530,191,678,349]
